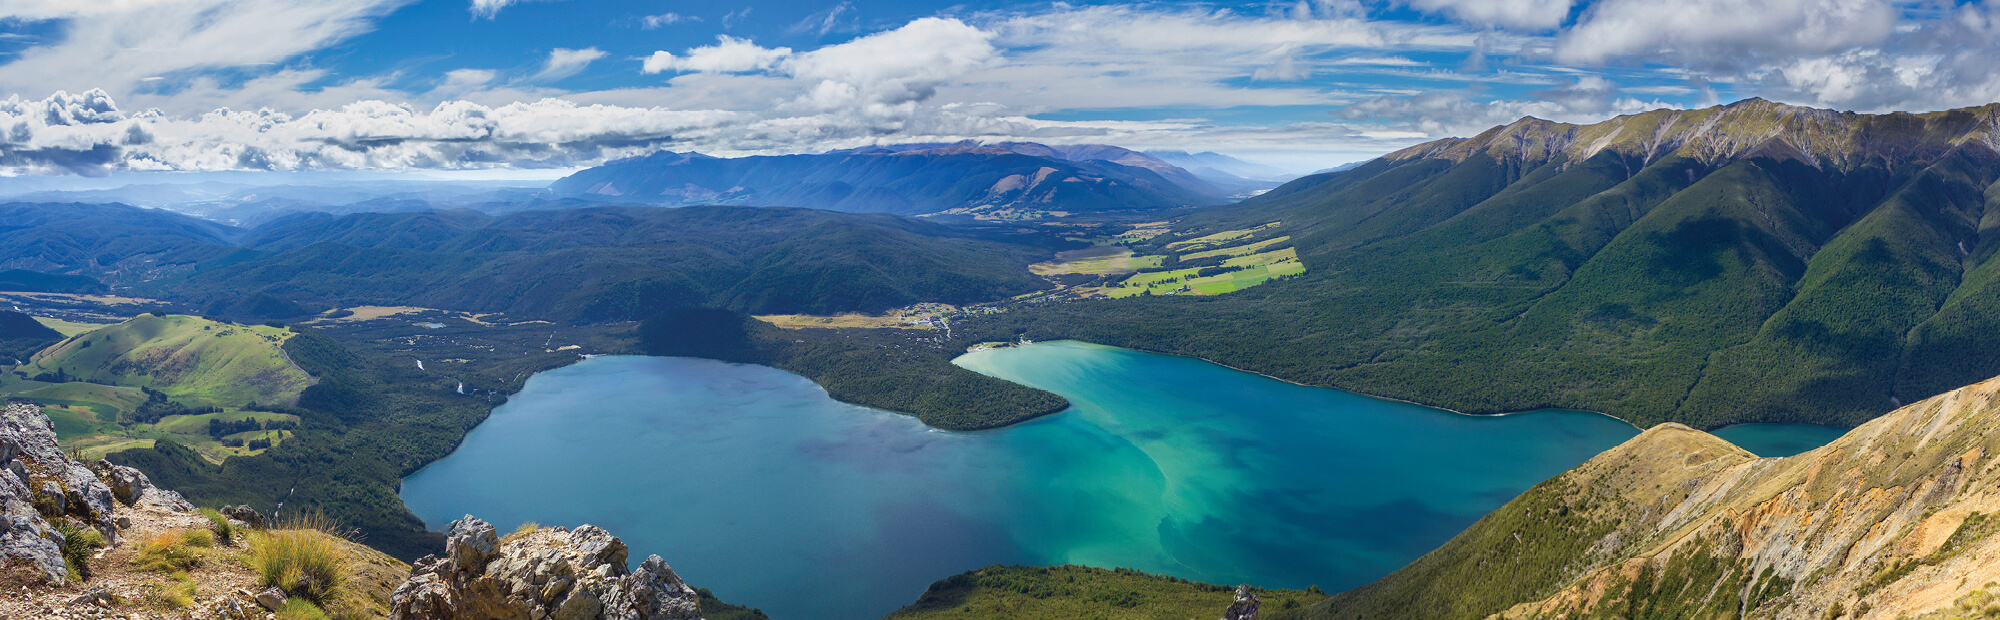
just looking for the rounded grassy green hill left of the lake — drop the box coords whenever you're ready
[16,314,312,408]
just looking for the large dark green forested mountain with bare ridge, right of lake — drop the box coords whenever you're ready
[992,100,2000,428]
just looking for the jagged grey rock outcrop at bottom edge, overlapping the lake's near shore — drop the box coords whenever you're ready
[390,514,700,620]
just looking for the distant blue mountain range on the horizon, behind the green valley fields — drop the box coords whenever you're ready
[550,144,1226,214]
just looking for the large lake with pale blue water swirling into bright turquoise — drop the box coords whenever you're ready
[402,342,1840,620]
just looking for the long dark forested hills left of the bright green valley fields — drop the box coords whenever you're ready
[0,204,1062,322]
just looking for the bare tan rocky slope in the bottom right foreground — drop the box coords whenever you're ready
[1312,378,2000,618]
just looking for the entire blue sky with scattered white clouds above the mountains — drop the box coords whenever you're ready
[0,0,2000,182]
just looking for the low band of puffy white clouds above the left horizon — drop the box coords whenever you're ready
[0,90,740,174]
